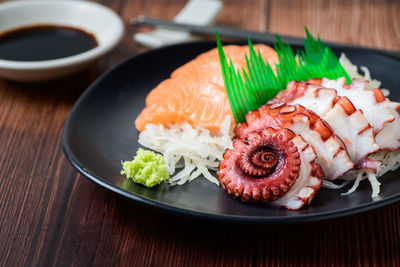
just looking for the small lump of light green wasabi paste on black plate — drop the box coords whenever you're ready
[121,148,169,187]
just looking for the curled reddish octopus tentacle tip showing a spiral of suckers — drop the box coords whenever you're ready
[218,128,301,202]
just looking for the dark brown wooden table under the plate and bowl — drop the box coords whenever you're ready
[0,0,400,266]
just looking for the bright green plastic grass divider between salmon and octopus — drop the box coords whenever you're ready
[216,28,351,123]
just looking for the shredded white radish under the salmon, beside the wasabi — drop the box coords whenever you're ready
[139,116,232,185]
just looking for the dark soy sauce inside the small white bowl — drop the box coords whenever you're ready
[0,25,98,61]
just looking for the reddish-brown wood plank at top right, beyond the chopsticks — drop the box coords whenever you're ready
[269,0,400,50]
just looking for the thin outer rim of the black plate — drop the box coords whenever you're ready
[62,41,400,223]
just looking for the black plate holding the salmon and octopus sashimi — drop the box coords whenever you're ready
[63,42,400,222]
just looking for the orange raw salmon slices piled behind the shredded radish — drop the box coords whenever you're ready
[135,44,279,136]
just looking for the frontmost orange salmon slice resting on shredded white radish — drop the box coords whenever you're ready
[135,79,231,133]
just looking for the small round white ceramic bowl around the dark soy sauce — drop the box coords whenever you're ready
[0,0,124,82]
